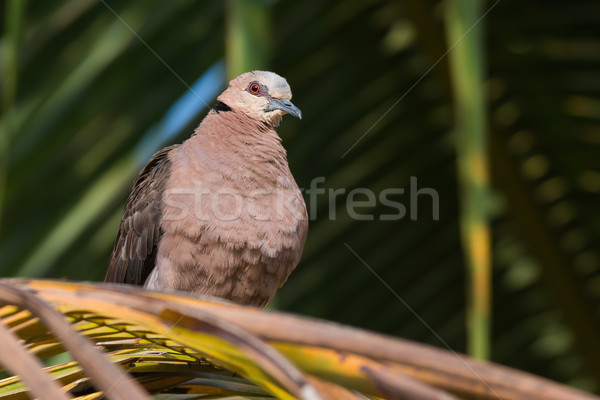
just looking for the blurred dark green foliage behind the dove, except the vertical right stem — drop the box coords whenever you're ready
[0,0,600,390]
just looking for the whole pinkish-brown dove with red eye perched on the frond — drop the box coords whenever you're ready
[104,71,308,307]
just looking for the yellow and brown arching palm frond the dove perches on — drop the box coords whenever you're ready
[0,279,598,400]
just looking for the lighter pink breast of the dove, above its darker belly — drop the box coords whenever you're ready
[163,142,307,257]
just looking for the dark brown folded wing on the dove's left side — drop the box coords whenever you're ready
[104,145,178,285]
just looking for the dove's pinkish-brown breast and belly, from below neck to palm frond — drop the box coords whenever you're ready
[155,148,308,306]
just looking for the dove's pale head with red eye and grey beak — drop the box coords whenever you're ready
[217,71,302,126]
